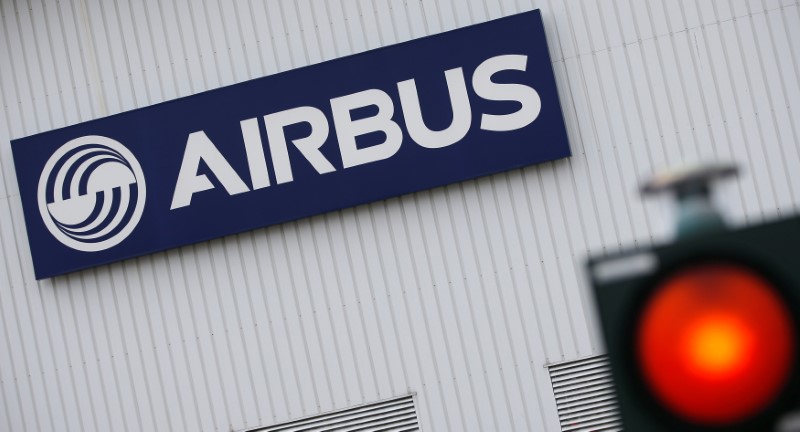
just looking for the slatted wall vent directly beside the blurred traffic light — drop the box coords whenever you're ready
[548,355,622,432]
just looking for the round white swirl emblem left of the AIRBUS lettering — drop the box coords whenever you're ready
[37,135,146,252]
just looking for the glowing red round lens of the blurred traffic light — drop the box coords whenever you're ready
[635,263,796,426]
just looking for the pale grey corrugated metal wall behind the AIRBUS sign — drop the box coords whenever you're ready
[0,0,800,432]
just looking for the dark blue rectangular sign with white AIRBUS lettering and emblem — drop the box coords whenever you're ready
[12,11,570,278]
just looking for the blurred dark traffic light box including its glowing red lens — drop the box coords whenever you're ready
[589,217,800,432]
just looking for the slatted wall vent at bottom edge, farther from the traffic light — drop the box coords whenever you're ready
[246,395,419,432]
